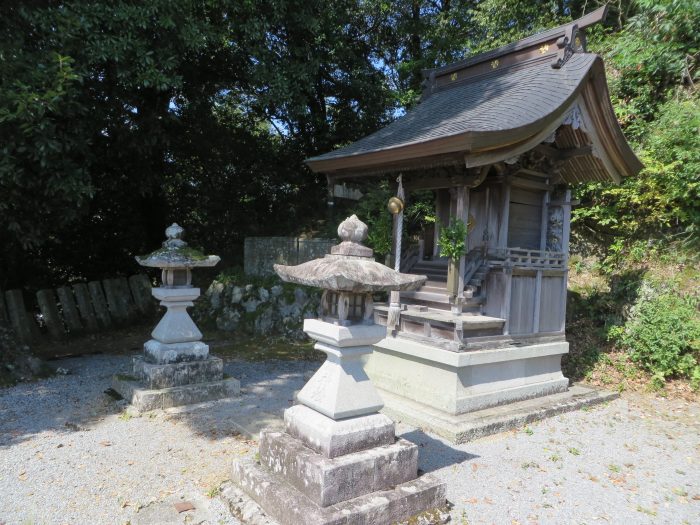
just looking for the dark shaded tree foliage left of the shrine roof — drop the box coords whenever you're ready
[0,0,391,288]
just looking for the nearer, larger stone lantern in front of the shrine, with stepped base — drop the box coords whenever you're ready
[228,215,445,525]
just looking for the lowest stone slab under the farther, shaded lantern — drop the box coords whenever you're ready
[112,375,241,412]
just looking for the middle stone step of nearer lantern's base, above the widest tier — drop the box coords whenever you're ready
[259,430,418,507]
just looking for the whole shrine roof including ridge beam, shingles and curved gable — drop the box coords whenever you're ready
[306,8,641,182]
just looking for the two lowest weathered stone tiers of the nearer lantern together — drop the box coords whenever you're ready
[230,431,445,525]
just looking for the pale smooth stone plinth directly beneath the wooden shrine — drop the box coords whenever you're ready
[365,337,569,416]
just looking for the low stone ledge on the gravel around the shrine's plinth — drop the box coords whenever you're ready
[379,385,619,444]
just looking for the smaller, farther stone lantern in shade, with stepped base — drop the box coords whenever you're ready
[112,223,240,410]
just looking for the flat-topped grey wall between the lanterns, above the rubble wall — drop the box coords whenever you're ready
[243,237,337,276]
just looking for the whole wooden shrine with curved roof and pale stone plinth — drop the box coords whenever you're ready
[307,8,642,440]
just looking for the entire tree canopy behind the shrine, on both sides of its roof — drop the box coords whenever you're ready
[0,0,700,288]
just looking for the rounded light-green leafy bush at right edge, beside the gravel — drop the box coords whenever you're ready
[609,283,700,388]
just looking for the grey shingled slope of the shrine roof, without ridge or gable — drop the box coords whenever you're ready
[308,54,597,163]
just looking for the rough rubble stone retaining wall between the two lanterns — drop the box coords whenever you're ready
[193,279,321,339]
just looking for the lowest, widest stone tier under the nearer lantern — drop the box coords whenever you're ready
[230,459,445,525]
